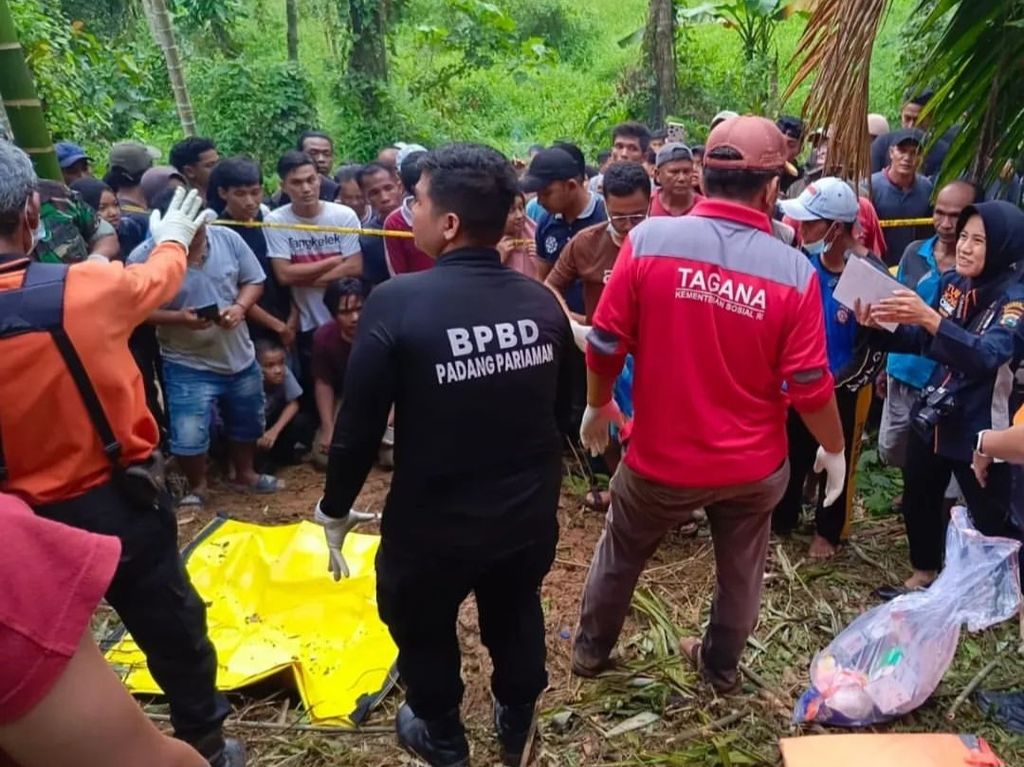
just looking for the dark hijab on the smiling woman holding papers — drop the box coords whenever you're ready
[956,200,1024,325]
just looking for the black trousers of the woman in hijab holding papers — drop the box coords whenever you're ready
[903,429,1021,570]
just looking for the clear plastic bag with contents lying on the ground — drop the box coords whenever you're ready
[793,507,1021,727]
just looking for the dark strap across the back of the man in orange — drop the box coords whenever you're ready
[0,263,122,481]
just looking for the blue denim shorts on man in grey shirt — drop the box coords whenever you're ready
[164,359,264,456]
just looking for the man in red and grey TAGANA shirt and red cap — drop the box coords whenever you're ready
[572,117,846,692]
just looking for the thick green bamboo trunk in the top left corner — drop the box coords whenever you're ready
[0,0,62,181]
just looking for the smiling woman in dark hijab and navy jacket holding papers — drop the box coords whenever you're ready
[857,202,1024,573]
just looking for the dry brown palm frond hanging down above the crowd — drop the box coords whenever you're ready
[782,0,889,183]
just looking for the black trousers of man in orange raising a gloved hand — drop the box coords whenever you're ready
[36,483,230,757]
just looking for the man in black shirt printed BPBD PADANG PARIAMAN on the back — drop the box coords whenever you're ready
[316,144,573,767]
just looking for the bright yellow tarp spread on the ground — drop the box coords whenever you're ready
[106,519,398,726]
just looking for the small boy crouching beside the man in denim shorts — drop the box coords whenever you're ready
[256,338,312,470]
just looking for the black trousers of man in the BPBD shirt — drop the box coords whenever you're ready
[377,524,558,722]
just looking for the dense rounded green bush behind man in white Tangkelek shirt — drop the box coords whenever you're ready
[191,60,319,168]
